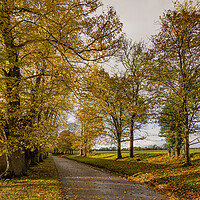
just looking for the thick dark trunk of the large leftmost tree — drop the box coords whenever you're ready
[1,5,26,176]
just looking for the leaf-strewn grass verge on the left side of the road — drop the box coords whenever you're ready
[0,157,62,200]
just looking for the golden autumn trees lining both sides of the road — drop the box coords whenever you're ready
[0,0,200,177]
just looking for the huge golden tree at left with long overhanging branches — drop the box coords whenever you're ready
[0,0,122,176]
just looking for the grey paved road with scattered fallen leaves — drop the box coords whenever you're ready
[53,156,166,200]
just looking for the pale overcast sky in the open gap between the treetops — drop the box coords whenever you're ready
[102,0,173,42]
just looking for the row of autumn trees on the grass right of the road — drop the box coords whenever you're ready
[57,1,200,165]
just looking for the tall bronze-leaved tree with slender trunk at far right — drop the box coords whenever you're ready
[149,1,200,165]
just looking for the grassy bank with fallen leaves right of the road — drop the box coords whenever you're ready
[63,150,200,200]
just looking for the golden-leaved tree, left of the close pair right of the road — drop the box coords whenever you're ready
[87,68,127,158]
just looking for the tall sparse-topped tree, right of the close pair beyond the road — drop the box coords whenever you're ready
[116,39,150,157]
